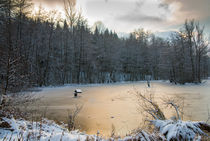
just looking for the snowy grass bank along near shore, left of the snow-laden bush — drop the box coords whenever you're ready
[0,118,156,141]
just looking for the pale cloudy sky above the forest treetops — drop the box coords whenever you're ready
[34,0,210,33]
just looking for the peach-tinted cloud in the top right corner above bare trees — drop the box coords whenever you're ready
[159,0,210,32]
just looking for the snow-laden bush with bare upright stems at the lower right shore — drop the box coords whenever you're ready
[135,91,210,141]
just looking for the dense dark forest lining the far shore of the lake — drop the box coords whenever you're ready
[0,0,209,93]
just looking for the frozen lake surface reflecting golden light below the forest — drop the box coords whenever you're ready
[35,80,210,136]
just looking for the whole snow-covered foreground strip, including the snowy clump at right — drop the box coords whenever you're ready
[0,118,209,141]
